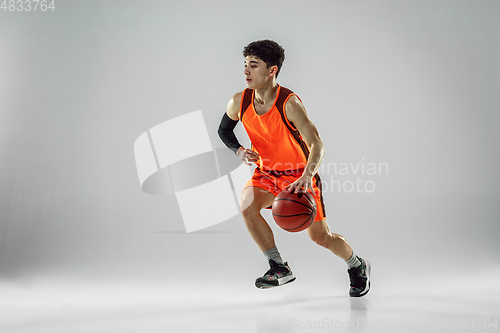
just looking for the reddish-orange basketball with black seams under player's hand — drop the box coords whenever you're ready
[272,191,317,232]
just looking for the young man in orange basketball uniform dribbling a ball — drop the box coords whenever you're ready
[218,40,371,297]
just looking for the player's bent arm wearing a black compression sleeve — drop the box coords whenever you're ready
[217,92,260,165]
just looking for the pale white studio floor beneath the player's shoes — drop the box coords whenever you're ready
[0,268,500,333]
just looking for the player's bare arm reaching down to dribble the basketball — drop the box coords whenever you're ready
[285,96,325,194]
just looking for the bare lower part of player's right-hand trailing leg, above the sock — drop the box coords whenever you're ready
[307,220,353,260]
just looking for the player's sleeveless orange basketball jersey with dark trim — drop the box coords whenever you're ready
[239,85,309,171]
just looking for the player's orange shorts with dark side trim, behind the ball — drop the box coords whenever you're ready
[243,168,326,222]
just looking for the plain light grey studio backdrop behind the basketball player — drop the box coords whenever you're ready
[0,0,500,308]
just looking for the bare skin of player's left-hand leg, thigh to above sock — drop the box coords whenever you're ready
[240,186,276,252]
